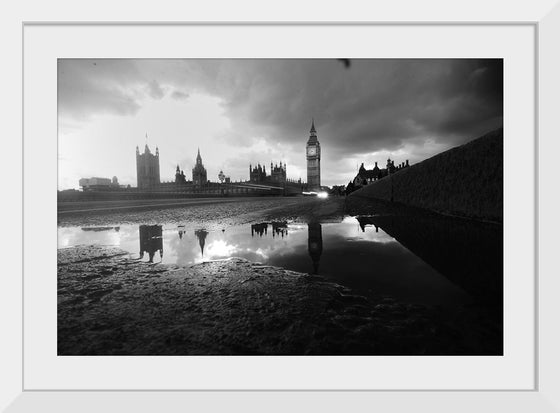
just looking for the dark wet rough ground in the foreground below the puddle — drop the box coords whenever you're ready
[58,245,503,355]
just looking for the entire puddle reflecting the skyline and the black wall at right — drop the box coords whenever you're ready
[58,216,503,307]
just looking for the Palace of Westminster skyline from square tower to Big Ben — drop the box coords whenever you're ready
[136,120,321,191]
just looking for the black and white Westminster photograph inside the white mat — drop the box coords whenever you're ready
[55,57,504,356]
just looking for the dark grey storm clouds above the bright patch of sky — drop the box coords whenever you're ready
[59,59,503,166]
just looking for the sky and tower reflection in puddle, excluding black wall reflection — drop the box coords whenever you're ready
[58,217,470,306]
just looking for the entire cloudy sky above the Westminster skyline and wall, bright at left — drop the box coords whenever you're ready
[58,59,503,189]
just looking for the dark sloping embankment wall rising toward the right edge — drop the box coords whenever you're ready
[348,129,503,222]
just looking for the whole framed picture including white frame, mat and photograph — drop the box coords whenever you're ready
[6,3,560,411]
